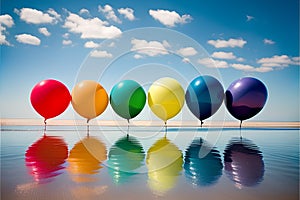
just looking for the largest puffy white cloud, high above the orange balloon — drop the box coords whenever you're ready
[63,13,122,39]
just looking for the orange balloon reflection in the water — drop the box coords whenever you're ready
[68,136,107,182]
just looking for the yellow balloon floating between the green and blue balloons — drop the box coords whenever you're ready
[148,77,185,122]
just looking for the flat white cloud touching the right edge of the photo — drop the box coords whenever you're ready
[257,55,299,67]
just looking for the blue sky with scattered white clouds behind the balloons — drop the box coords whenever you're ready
[0,0,299,121]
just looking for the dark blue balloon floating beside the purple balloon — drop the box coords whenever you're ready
[185,76,224,123]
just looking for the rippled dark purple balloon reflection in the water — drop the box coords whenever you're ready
[224,138,265,188]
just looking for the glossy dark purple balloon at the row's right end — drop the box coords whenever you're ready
[225,77,268,121]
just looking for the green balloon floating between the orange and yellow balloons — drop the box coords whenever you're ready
[110,80,146,120]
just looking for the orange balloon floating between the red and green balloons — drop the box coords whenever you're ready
[71,80,108,120]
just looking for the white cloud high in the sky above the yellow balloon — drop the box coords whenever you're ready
[149,9,193,27]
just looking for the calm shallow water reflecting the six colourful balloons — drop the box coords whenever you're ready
[1,126,299,199]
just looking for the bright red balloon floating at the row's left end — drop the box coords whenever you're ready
[30,79,71,120]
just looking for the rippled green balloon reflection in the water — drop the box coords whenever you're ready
[107,136,145,184]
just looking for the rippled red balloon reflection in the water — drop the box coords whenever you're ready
[25,135,68,183]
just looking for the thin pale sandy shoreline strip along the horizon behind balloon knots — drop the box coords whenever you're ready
[0,119,300,128]
